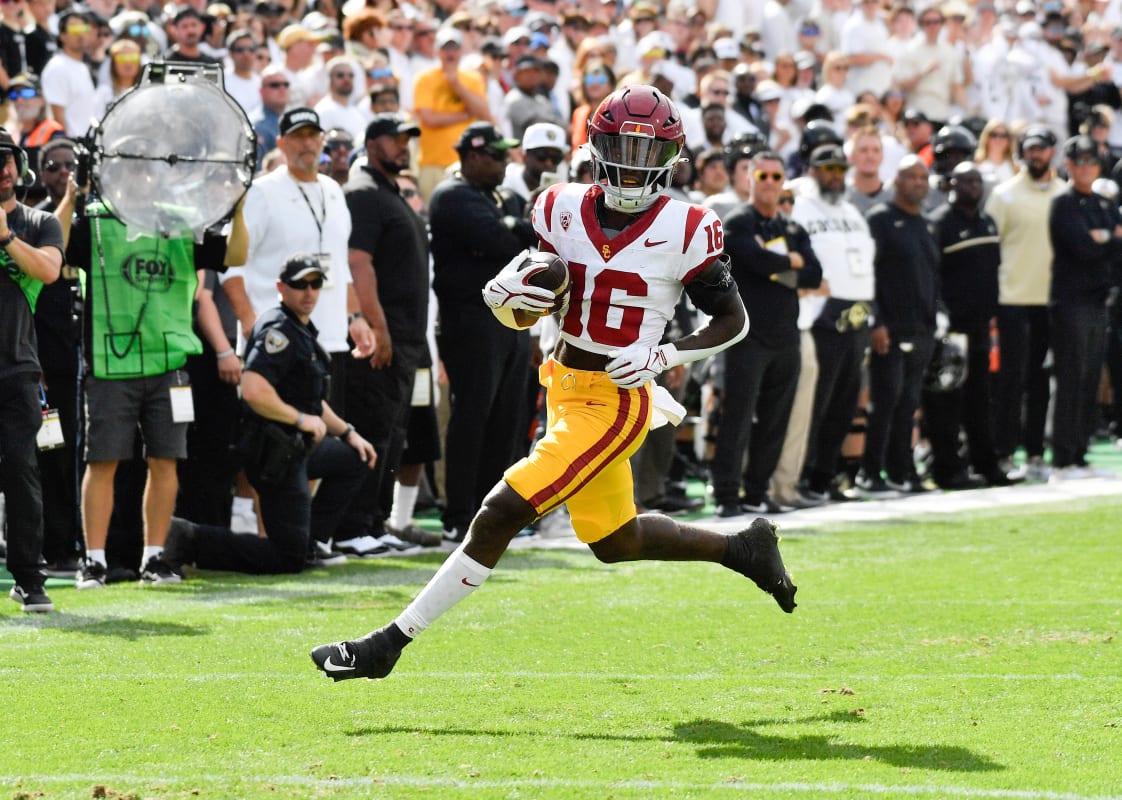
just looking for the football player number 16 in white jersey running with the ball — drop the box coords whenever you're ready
[311,85,795,681]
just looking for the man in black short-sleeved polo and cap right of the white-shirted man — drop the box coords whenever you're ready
[334,113,429,550]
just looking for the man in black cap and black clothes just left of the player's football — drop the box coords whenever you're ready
[429,122,537,543]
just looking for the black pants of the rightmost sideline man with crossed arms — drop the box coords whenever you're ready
[1049,303,1106,467]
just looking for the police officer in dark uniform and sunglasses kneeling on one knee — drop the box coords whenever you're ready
[164,254,377,574]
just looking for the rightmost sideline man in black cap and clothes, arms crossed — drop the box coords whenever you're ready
[1048,136,1122,477]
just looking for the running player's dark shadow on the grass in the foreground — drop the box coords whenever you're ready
[347,711,1005,772]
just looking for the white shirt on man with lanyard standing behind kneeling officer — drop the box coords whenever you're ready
[222,167,351,352]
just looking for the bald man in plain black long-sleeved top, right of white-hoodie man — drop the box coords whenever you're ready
[856,156,939,496]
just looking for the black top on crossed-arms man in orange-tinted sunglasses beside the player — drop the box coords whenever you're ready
[725,203,822,348]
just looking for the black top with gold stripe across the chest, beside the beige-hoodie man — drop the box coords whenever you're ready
[931,200,1001,319]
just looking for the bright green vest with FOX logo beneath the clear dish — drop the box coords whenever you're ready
[85,203,203,379]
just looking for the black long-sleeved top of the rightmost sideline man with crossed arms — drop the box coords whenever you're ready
[1048,187,1122,305]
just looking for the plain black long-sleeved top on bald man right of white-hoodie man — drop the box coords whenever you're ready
[867,203,939,341]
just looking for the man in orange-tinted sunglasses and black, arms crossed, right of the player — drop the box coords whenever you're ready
[711,151,822,517]
